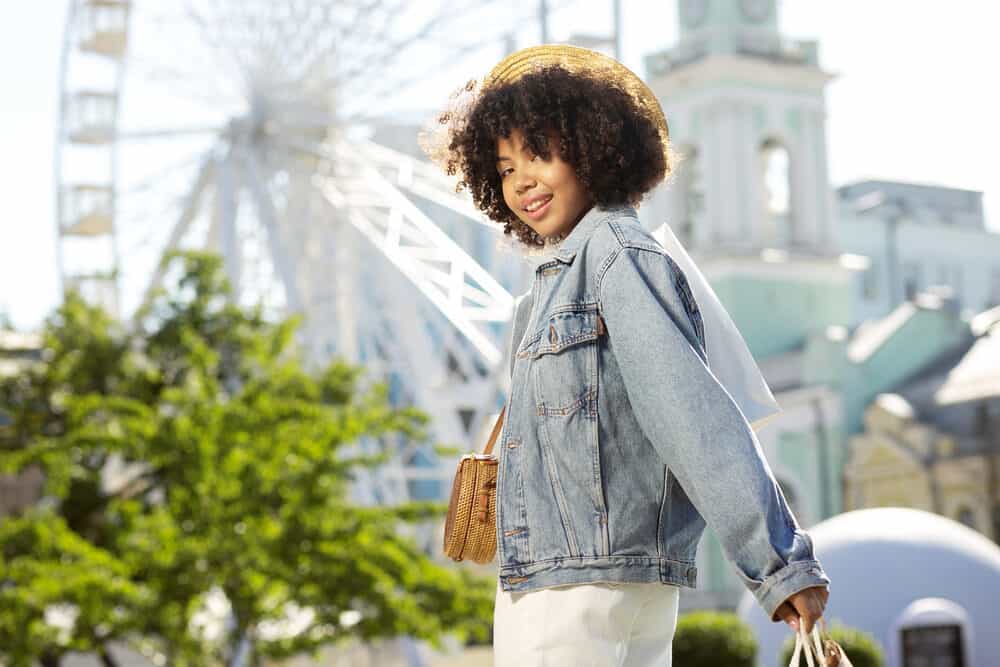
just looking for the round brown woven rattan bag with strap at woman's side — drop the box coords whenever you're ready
[444,408,506,563]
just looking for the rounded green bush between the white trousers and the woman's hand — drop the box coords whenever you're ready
[674,611,757,667]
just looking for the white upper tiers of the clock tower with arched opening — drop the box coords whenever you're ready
[646,0,835,255]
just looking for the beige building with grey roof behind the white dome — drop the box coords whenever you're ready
[844,307,1000,542]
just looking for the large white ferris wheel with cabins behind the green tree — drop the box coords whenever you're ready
[54,0,620,516]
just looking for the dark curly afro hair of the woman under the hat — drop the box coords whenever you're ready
[422,65,673,246]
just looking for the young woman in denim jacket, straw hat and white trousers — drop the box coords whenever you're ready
[424,45,829,667]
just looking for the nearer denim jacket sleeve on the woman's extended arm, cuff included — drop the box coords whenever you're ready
[599,247,830,619]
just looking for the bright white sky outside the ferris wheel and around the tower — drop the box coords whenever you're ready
[0,0,1000,328]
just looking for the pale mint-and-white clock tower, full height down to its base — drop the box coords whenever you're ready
[639,0,866,608]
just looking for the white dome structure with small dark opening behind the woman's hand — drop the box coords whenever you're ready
[738,507,1000,667]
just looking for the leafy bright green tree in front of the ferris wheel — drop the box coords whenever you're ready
[0,253,493,666]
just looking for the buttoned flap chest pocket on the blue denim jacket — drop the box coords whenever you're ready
[518,305,605,417]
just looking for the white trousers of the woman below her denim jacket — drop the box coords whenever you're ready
[493,581,680,667]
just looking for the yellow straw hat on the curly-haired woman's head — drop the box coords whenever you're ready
[483,44,670,147]
